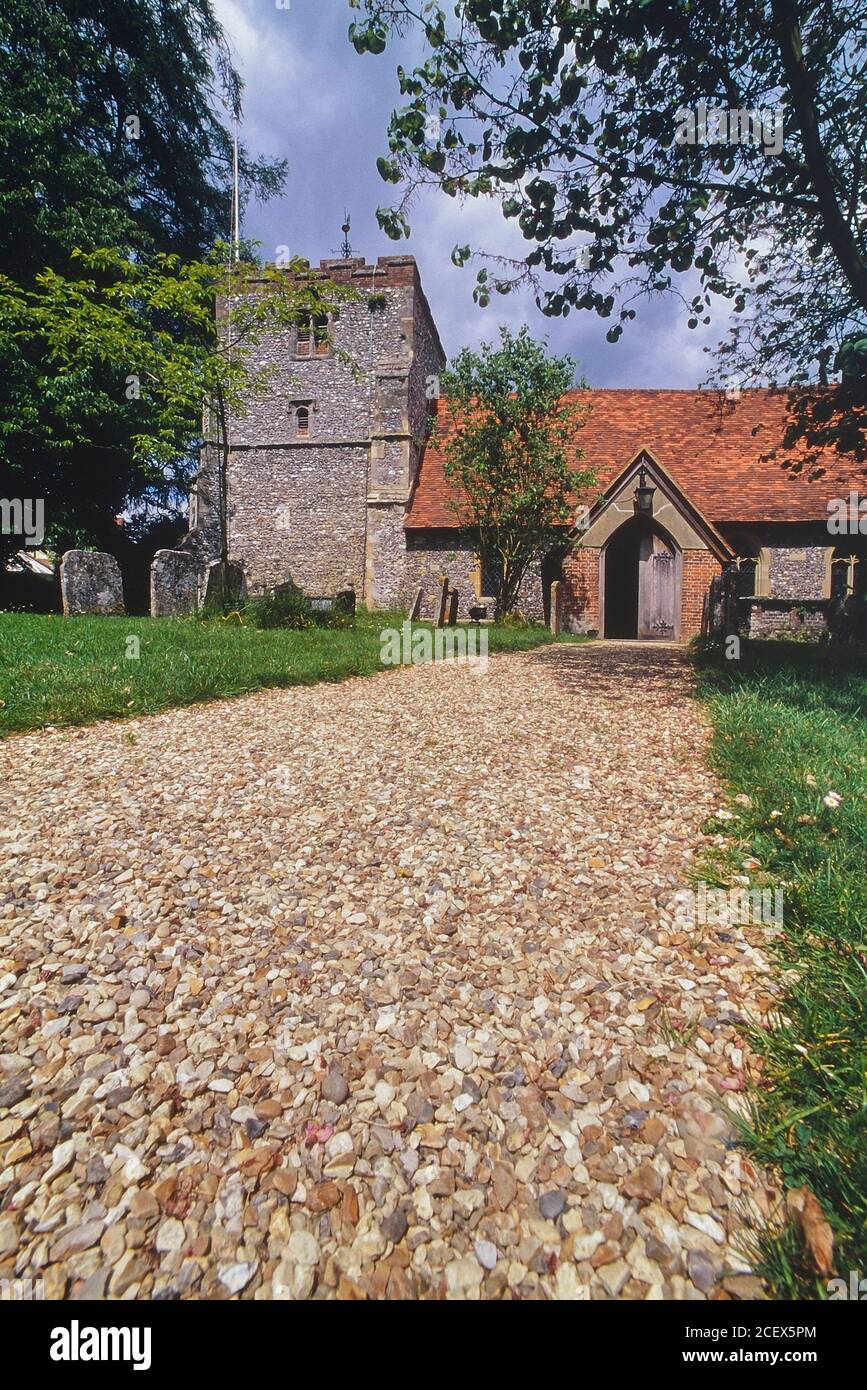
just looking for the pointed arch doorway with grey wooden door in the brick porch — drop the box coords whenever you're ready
[599,516,682,642]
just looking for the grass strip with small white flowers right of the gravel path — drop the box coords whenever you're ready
[697,642,867,1298]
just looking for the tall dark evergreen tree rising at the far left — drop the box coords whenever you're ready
[0,0,283,585]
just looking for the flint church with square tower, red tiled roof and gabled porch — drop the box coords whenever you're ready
[189,256,867,641]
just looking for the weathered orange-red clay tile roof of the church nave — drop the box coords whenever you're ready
[404,389,863,531]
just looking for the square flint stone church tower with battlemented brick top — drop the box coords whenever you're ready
[188,256,445,607]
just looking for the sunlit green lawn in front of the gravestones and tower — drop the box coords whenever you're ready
[0,613,589,737]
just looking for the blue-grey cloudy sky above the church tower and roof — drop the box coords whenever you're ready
[215,0,725,386]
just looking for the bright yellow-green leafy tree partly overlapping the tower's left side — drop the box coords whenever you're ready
[0,243,354,592]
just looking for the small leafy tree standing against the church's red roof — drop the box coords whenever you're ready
[442,327,595,617]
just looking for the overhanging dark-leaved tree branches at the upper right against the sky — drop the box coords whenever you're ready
[350,0,867,467]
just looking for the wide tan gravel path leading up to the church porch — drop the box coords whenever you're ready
[0,644,770,1298]
